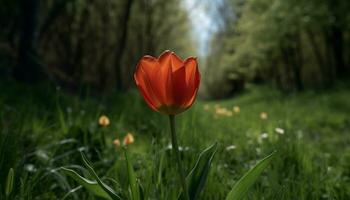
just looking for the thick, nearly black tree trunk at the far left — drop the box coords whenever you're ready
[13,0,44,83]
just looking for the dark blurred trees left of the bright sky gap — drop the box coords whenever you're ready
[0,0,194,92]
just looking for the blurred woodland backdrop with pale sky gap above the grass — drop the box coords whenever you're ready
[0,0,350,98]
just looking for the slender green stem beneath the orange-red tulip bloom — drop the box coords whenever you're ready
[169,115,190,200]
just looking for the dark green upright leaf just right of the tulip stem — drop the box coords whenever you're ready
[180,143,217,200]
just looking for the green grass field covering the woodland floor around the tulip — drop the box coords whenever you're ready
[0,82,350,200]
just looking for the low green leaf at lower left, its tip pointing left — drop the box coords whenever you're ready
[61,167,112,200]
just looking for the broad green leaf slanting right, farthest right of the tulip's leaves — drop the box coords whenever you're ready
[226,152,276,200]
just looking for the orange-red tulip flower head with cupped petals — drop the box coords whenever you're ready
[134,51,200,115]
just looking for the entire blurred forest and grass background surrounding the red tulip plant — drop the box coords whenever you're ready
[0,0,350,200]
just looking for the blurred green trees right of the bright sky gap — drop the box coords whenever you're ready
[204,0,350,97]
